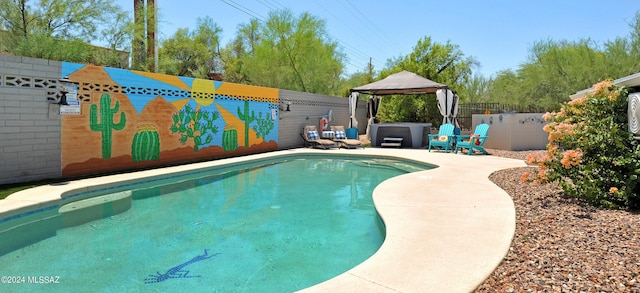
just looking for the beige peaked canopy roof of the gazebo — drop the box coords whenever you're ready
[351,70,448,96]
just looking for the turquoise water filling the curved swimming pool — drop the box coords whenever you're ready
[0,157,428,292]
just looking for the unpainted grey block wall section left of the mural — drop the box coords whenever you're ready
[0,54,62,184]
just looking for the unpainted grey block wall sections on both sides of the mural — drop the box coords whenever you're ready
[0,54,367,184]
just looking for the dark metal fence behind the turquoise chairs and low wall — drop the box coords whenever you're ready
[457,103,549,130]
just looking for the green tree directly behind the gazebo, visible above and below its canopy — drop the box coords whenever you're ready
[378,37,479,125]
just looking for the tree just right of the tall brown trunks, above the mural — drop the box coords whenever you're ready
[158,17,222,79]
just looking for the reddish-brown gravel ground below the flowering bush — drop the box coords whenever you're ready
[476,150,640,292]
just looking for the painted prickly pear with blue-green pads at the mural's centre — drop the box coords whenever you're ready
[170,105,220,152]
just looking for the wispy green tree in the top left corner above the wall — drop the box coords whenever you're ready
[0,0,129,62]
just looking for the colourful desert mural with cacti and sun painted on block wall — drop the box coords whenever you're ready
[62,62,279,176]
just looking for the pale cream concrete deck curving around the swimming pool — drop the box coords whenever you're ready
[0,148,526,292]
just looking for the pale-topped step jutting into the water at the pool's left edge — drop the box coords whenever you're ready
[58,190,131,227]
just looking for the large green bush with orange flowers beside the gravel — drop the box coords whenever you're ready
[521,80,640,208]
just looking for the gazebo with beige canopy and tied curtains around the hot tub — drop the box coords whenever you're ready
[350,70,458,148]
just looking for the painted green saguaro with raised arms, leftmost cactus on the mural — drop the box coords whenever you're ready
[89,94,127,159]
